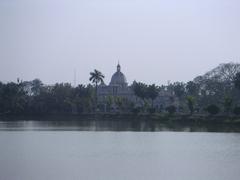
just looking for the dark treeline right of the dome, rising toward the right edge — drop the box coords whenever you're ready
[124,63,240,115]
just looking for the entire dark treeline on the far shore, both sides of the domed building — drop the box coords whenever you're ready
[0,63,240,115]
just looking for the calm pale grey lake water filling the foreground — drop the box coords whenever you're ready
[0,121,240,180]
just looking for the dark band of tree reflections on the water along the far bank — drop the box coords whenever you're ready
[0,119,240,132]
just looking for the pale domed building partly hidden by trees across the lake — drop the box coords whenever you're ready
[97,64,177,110]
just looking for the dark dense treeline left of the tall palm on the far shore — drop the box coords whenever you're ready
[0,79,95,114]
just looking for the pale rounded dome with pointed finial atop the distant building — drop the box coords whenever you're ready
[110,64,127,86]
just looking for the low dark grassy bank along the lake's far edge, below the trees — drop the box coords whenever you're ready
[0,113,240,125]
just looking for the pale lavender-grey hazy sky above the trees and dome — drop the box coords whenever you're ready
[0,0,240,84]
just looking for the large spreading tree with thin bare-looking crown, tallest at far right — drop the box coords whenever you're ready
[193,63,240,111]
